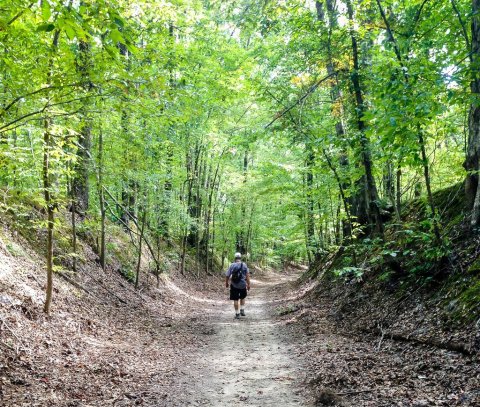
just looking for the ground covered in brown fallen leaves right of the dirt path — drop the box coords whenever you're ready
[274,278,480,407]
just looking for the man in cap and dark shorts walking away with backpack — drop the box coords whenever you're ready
[225,253,250,319]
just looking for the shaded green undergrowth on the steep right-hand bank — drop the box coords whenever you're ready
[308,185,480,322]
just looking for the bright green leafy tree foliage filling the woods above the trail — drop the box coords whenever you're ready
[0,0,471,278]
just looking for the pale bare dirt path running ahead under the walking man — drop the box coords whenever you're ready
[171,274,308,407]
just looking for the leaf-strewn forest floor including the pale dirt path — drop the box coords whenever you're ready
[0,244,480,407]
